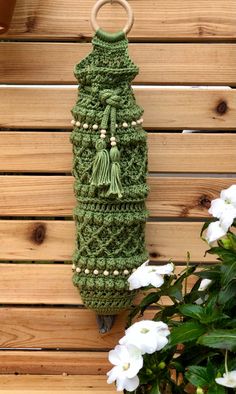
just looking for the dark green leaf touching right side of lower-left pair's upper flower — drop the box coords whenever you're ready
[168,321,206,347]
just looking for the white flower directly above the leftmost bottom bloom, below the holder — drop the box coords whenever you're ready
[119,320,170,354]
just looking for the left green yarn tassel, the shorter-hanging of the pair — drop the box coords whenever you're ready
[91,139,111,186]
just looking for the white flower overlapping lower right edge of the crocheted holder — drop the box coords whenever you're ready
[128,261,174,290]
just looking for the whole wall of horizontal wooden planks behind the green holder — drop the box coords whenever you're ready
[0,0,236,394]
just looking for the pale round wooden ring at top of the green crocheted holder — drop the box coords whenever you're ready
[91,0,134,34]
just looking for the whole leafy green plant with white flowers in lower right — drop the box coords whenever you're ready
[108,185,236,394]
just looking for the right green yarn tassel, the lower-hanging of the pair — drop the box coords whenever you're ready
[107,146,123,198]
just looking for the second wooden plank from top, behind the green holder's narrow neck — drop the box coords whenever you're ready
[0,42,236,86]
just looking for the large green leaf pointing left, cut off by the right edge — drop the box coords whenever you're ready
[197,329,236,352]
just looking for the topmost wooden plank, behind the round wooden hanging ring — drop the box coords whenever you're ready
[5,0,236,41]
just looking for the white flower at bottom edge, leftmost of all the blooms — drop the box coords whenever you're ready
[107,345,143,391]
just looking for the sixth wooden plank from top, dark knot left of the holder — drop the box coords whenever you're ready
[0,220,214,262]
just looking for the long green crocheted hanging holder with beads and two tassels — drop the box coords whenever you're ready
[71,30,148,315]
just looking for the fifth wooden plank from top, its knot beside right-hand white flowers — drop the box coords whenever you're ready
[0,175,233,218]
